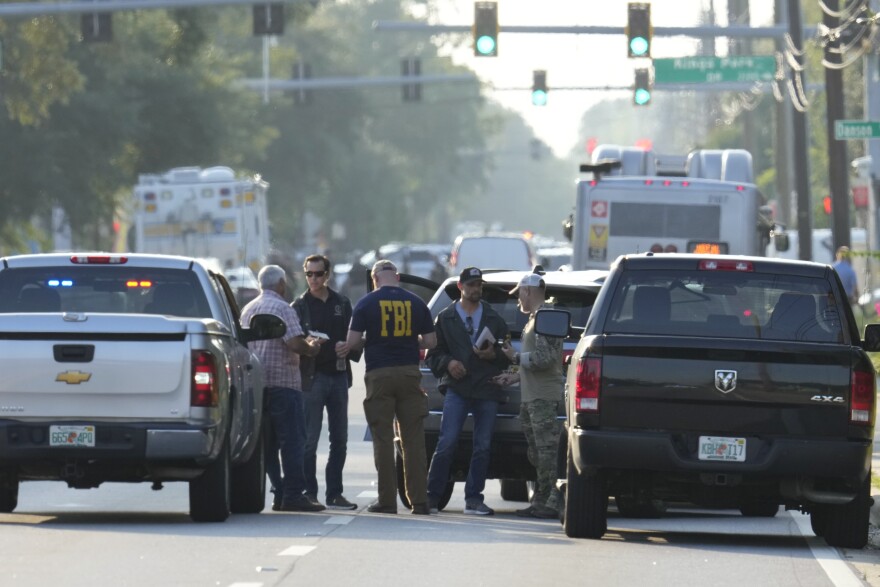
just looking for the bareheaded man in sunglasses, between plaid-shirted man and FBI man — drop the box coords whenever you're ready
[291,255,361,510]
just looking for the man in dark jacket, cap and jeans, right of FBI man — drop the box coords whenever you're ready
[425,267,509,516]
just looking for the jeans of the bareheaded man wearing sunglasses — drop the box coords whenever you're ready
[303,371,348,500]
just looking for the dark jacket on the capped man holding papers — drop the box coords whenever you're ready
[425,301,510,400]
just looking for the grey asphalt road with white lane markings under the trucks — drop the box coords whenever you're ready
[0,362,880,587]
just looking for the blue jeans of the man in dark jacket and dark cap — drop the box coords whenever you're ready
[428,389,498,503]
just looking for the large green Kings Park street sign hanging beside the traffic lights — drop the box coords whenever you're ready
[654,55,776,84]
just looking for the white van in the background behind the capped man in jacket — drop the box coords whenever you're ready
[449,233,536,275]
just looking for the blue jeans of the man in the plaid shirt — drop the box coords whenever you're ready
[266,387,306,502]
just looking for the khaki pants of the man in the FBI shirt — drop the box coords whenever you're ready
[364,365,428,507]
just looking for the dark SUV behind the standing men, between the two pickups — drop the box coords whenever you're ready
[397,271,607,509]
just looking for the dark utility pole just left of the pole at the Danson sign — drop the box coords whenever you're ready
[788,0,813,261]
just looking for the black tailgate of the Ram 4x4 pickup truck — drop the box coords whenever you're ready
[600,335,853,438]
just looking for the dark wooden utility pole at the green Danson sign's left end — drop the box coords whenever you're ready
[822,0,850,251]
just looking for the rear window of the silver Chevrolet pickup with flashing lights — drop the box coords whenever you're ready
[0,265,211,318]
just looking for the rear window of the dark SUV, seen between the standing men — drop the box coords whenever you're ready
[431,283,598,338]
